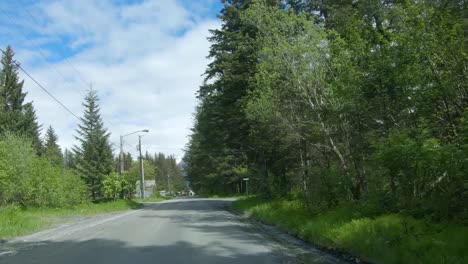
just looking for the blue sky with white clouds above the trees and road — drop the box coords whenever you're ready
[0,0,222,159]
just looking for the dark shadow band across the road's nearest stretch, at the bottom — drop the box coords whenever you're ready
[0,239,276,264]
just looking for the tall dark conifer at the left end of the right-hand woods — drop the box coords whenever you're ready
[186,0,280,193]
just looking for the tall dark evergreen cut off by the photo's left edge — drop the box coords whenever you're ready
[0,46,41,154]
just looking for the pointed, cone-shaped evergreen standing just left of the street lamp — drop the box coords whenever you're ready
[74,89,114,200]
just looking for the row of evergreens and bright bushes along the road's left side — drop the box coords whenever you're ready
[0,46,186,207]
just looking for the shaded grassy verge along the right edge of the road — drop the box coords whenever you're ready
[233,197,468,264]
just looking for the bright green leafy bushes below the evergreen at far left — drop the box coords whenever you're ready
[0,133,87,207]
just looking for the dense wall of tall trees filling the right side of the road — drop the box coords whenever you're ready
[184,0,468,219]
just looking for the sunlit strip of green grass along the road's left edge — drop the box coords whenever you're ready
[0,200,141,240]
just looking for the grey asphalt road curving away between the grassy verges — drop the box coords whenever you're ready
[0,199,300,264]
